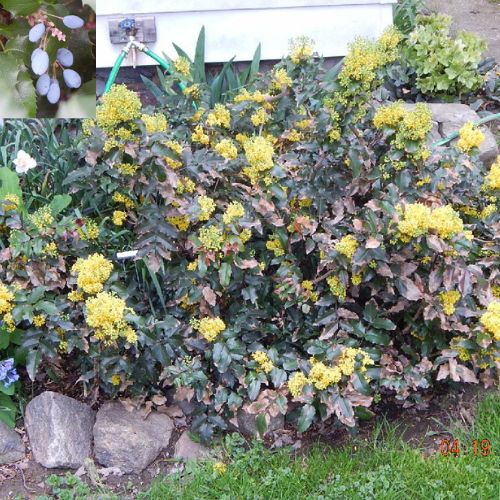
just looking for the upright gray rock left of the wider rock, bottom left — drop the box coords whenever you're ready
[25,391,94,469]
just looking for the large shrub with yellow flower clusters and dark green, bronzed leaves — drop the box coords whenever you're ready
[0,30,500,438]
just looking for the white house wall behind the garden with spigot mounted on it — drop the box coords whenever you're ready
[96,0,396,68]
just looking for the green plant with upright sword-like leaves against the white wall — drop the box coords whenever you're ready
[141,27,260,106]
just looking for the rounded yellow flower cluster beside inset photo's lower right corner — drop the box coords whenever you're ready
[96,85,142,131]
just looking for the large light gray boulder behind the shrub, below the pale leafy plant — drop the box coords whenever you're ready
[407,103,498,166]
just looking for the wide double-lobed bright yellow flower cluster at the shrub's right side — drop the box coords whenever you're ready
[398,203,464,242]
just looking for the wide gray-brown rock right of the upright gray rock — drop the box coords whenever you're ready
[94,403,174,474]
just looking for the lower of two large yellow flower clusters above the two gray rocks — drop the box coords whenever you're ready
[85,292,137,345]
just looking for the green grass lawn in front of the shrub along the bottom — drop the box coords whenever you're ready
[140,394,500,500]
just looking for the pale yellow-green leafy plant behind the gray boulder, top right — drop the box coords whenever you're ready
[401,14,486,98]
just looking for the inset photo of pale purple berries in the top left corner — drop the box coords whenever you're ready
[0,0,96,118]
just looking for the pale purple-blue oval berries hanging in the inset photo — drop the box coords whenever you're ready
[28,16,84,104]
